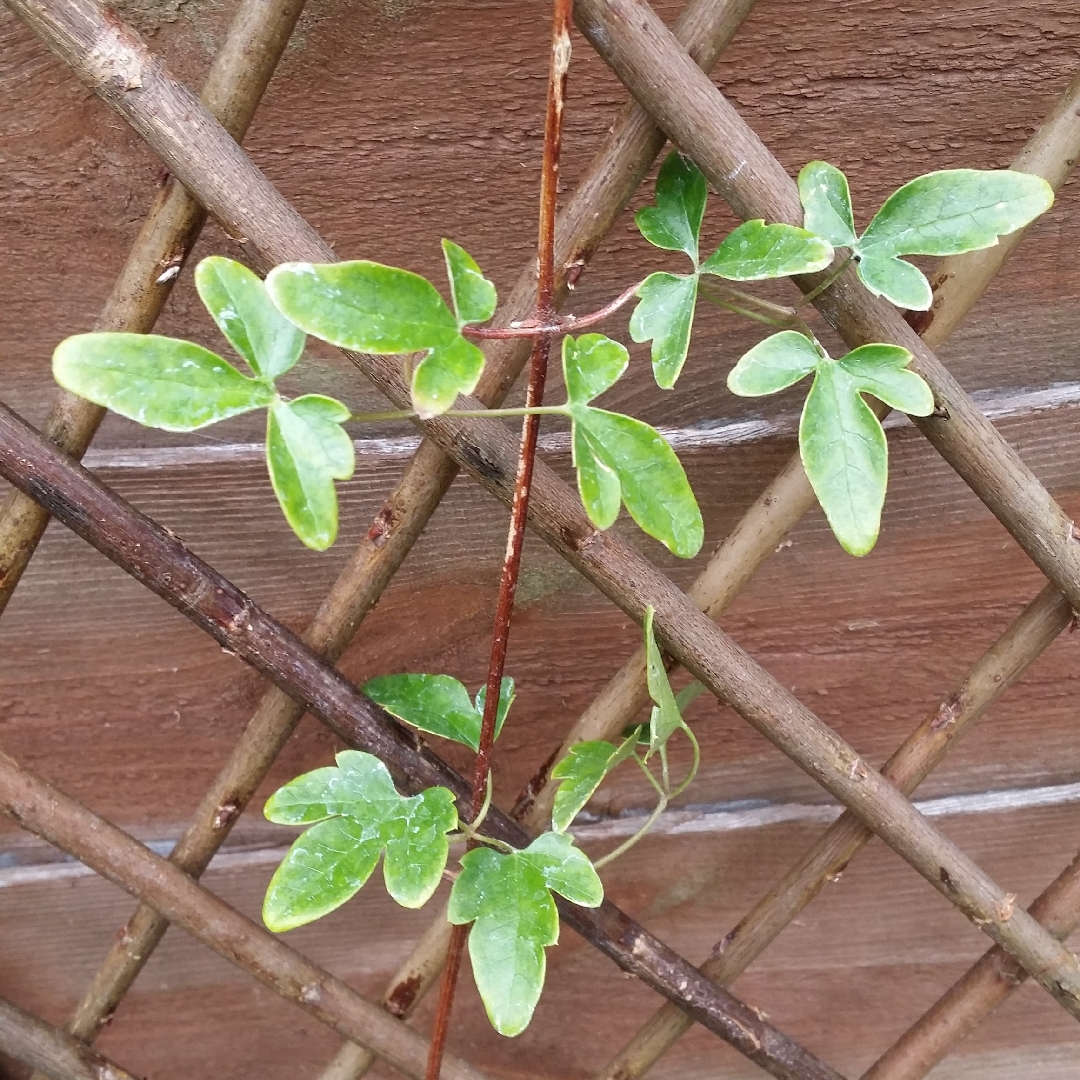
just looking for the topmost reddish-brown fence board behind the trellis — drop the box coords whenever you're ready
[0,0,1080,445]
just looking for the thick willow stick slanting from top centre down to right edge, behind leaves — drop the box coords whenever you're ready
[575,0,1080,610]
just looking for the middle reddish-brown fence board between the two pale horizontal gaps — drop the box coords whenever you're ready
[0,410,1080,825]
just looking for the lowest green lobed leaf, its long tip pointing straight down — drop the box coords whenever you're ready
[447,833,604,1036]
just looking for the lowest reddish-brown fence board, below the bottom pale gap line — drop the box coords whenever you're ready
[0,804,1080,1080]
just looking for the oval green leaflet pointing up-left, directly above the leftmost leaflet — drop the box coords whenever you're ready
[195,255,305,382]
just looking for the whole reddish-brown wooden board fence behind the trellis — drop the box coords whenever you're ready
[0,0,1080,1080]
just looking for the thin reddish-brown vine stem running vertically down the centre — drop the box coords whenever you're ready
[427,0,573,1080]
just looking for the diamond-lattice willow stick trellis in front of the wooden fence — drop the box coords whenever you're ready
[0,0,1080,1080]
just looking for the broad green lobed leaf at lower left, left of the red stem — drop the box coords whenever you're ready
[262,751,458,932]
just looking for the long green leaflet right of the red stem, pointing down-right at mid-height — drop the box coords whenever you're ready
[570,405,705,558]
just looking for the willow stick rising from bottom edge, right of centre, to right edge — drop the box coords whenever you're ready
[599,585,1072,1080]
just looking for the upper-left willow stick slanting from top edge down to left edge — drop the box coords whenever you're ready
[0,0,305,617]
